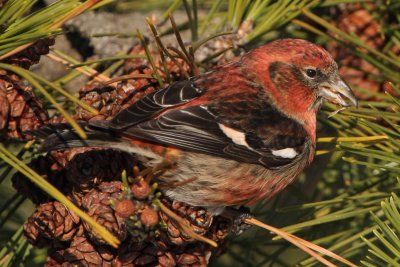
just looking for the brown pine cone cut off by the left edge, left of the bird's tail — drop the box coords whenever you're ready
[0,70,48,140]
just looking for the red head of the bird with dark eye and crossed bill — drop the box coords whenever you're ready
[243,39,357,123]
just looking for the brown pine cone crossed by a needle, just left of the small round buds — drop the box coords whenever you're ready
[82,181,127,245]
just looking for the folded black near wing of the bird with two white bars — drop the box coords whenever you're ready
[108,106,307,168]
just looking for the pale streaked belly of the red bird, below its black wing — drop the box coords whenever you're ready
[155,152,295,207]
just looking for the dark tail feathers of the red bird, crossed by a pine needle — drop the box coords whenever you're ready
[25,123,121,152]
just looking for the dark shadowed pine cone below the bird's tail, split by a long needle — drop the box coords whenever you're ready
[11,154,71,204]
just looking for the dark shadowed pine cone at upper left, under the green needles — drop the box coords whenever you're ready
[4,38,54,69]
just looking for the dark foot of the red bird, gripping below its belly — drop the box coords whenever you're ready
[220,206,253,235]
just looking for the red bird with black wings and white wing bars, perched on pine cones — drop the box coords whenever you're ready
[36,39,357,212]
